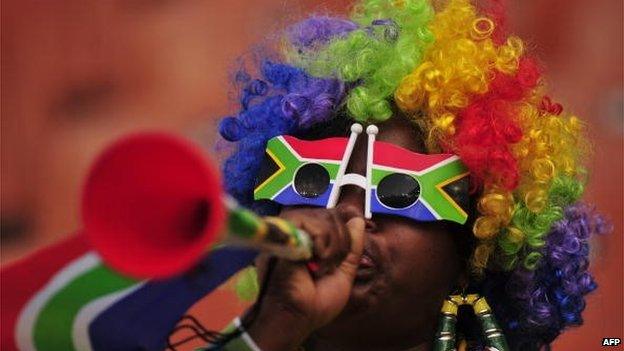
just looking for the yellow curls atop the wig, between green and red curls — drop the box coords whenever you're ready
[394,0,523,152]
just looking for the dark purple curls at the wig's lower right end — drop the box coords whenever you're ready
[484,203,610,350]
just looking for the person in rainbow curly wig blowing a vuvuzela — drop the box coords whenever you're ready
[212,0,608,351]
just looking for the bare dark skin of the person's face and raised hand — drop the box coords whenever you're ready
[249,117,466,351]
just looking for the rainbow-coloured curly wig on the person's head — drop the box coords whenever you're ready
[220,0,608,350]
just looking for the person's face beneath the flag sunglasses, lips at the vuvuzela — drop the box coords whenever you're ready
[285,117,463,347]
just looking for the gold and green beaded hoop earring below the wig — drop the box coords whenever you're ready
[433,294,509,351]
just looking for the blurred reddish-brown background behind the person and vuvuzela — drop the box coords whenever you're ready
[0,0,624,350]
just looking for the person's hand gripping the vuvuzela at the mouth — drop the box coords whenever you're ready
[249,208,365,350]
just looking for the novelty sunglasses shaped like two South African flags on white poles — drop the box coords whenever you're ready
[254,123,470,224]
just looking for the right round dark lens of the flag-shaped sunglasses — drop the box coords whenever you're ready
[377,173,420,208]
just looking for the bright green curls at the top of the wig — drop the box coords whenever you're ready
[286,0,434,122]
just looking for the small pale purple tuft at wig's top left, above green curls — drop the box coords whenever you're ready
[287,16,358,50]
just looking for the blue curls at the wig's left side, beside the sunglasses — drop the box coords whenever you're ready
[219,61,345,214]
